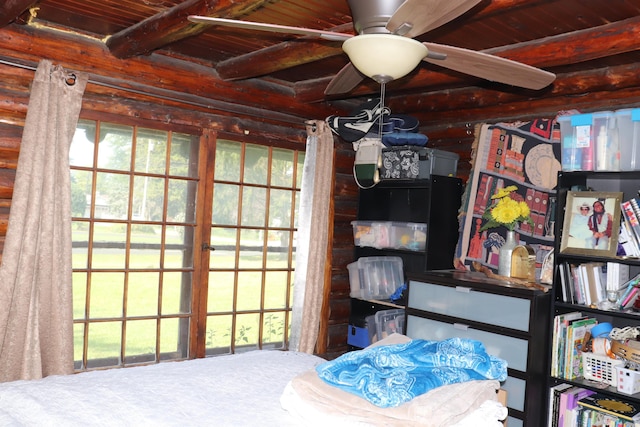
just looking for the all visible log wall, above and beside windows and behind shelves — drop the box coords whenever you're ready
[0,22,640,356]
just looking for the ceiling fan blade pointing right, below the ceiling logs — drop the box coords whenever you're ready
[423,42,556,90]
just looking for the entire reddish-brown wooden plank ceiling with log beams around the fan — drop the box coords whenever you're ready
[0,0,640,108]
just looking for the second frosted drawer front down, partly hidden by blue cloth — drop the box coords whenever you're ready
[406,315,529,372]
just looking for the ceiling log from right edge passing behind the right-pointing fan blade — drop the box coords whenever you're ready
[294,17,640,102]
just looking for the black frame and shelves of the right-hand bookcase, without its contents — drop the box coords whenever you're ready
[548,171,640,424]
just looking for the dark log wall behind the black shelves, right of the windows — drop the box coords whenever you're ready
[326,67,640,356]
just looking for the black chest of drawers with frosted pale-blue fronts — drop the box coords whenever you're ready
[406,270,550,427]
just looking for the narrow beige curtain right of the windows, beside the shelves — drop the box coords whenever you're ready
[289,120,334,353]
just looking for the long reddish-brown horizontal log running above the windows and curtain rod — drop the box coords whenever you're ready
[0,25,339,123]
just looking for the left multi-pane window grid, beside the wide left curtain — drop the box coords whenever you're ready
[70,120,199,370]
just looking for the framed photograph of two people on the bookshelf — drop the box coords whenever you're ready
[560,191,623,257]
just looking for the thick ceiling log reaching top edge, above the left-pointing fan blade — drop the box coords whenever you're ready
[106,0,276,59]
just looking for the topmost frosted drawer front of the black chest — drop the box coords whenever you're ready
[407,280,531,332]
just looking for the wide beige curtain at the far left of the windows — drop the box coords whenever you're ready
[0,60,88,381]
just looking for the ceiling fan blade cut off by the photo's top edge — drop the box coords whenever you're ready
[387,0,482,38]
